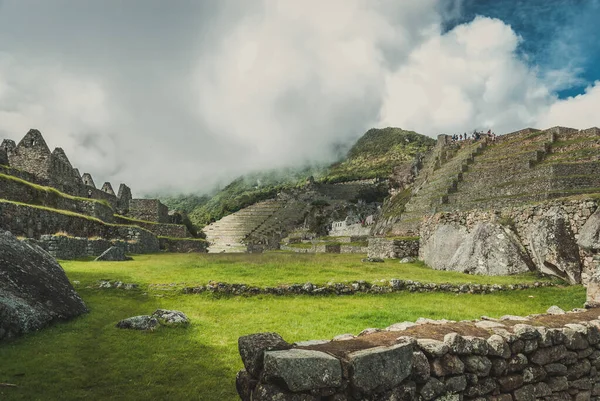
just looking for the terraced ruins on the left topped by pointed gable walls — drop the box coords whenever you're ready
[0,129,206,257]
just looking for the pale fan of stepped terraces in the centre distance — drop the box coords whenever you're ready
[203,200,283,253]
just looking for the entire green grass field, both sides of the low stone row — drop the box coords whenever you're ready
[0,253,585,400]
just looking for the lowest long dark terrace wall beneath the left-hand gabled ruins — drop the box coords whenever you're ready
[0,201,159,253]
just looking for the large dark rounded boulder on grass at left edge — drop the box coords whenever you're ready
[0,230,87,340]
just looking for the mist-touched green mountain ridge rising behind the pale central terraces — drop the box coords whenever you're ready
[161,128,435,226]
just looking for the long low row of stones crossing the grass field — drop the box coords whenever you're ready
[182,279,555,295]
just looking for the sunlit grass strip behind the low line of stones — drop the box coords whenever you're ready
[62,252,556,286]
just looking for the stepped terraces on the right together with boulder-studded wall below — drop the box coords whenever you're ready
[372,123,600,283]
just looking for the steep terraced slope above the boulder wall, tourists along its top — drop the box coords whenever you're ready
[448,127,600,211]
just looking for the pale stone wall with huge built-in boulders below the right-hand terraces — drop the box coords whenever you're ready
[420,199,600,283]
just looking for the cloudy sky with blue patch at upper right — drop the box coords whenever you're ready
[0,0,600,196]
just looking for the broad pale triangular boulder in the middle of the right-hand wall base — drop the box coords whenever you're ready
[447,222,533,276]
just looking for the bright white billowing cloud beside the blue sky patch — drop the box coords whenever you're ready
[380,17,552,135]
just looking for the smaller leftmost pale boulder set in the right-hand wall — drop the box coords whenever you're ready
[419,224,467,270]
